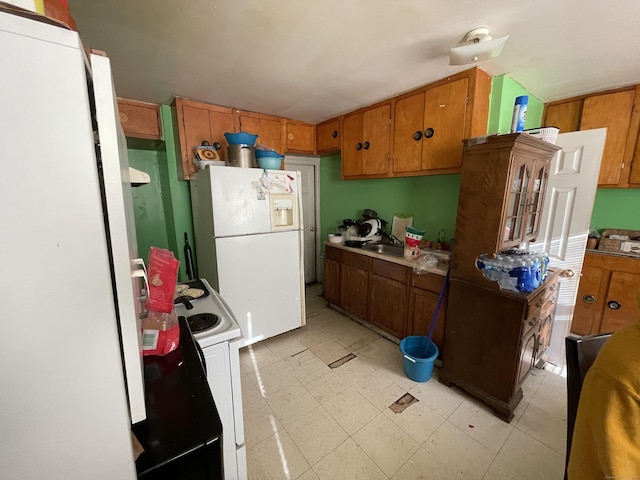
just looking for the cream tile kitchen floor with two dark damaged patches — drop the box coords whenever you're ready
[240,284,566,480]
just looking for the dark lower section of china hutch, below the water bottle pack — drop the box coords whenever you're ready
[439,272,559,422]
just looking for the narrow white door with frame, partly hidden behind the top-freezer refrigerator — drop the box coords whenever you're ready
[285,156,319,283]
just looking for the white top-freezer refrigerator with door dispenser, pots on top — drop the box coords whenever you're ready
[190,166,305,346]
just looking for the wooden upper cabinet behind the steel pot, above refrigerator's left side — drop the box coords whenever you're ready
[174,97,234,180]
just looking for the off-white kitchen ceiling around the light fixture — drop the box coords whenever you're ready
[69,0,640,123]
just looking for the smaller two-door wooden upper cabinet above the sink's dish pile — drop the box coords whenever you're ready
[342,103,391,178]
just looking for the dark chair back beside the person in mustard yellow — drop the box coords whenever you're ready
[564,333,612,480]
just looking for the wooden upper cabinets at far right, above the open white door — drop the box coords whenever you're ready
[543,86,640,187]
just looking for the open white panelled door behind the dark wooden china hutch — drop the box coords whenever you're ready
[529,128,607,365]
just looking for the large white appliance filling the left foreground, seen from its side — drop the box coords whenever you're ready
[0,12,145,480]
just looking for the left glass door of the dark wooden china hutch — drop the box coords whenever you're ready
[502,161,531,247]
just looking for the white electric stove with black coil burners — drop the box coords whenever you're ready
[175,278,247,480]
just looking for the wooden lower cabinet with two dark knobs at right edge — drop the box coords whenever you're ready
[571,251,640,335]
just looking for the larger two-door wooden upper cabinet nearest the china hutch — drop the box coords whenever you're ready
[393,69,491,176]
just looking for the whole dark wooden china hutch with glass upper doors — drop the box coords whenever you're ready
[439,134,559,422]
